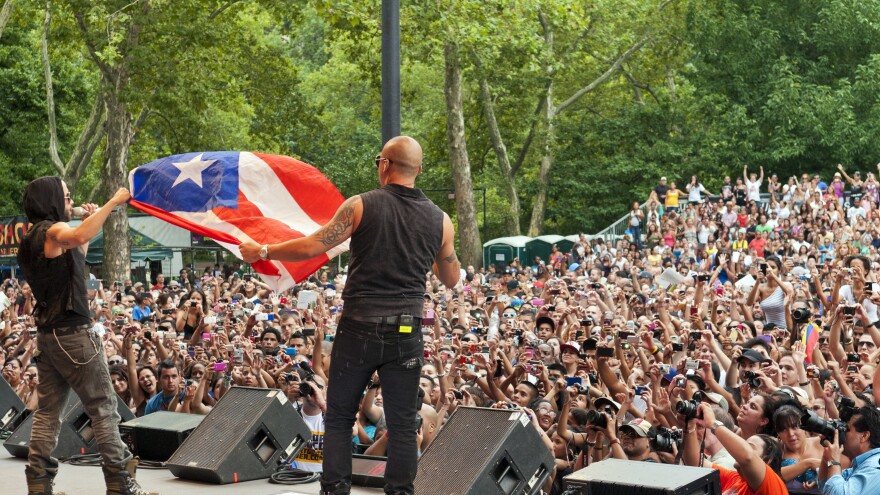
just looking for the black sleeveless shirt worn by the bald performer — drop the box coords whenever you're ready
[342,184,443,317]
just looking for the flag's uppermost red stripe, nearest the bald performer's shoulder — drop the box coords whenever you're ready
[254,153,345,225]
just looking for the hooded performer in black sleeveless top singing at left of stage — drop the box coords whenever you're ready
[18,177,155,495]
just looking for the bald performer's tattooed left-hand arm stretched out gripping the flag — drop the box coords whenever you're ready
[239,196,364,263]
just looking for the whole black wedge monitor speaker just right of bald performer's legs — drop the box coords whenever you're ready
[415,407,555,495]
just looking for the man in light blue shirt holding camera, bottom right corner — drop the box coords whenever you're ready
[819,406,880,495]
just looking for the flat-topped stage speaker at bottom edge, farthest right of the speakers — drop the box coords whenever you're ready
[564,459,721,495]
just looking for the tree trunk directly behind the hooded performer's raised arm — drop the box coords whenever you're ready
[104,80,134,280]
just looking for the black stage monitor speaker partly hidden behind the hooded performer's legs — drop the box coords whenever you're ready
[3,390,134,459]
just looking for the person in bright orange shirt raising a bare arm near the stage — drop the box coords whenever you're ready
[683,403,788,495]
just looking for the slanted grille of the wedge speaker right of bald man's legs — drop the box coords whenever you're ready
[416,407,522,494]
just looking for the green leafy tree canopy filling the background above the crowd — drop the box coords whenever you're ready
[0,0,880,268]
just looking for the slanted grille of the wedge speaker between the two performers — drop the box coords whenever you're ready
[173,387,272,469]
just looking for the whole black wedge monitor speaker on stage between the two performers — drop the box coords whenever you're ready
[167,387,312,483]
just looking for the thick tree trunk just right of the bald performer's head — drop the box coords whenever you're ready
[445,42,483,266]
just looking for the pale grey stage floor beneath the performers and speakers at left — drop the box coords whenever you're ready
[0,454,383,495]
